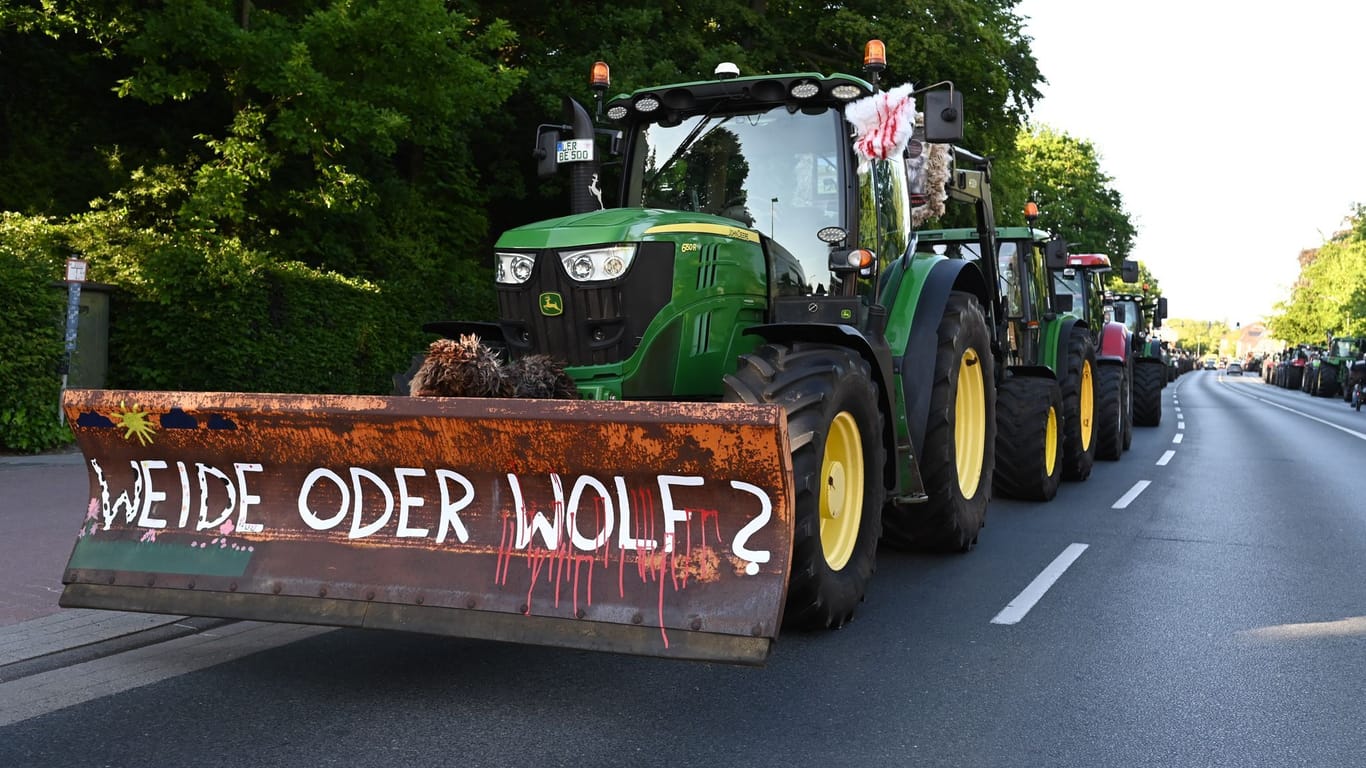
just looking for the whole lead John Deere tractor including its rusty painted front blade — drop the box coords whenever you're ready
[61,41,1032,664]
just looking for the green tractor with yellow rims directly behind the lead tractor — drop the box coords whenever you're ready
[917,218,1097,500]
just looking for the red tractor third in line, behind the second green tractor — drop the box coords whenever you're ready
[1048,247,1137,461]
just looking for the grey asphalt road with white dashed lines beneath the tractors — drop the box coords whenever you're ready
[0,372,1366,768]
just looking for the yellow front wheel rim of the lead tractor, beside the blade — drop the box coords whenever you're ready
[821,411,867,571]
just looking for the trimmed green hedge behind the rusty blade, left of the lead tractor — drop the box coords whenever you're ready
[0,212,493,451]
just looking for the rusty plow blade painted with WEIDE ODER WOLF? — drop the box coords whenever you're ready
[61,389,794,664]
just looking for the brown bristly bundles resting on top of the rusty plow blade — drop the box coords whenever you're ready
[408,333,579,400]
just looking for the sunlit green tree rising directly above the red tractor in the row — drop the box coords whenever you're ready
[1016,126,1152,256]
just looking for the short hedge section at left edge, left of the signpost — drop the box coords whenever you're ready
[0,216,71,452]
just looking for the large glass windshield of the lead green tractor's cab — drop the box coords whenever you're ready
[624,107,846,291]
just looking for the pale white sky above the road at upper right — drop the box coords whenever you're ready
[1016,0,1366,325]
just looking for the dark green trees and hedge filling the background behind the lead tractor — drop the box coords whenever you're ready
[0,0,1042,440]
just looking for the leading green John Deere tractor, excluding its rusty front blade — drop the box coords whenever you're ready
[426,47,1010,645]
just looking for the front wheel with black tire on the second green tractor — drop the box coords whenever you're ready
[992,376,1063,502]
